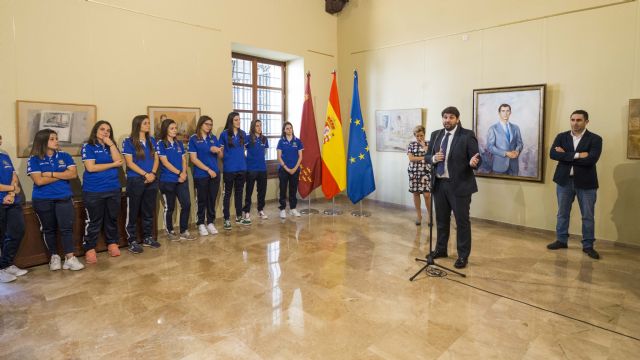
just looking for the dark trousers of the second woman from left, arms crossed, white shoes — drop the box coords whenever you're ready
[31,198,75,255]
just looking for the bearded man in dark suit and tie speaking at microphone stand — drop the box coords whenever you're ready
[425,106,481,269]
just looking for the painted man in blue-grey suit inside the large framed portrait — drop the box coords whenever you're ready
[487,104,524,176]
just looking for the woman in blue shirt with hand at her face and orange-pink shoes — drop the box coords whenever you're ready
[82,120,124,264]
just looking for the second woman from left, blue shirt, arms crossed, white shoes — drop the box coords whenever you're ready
[27,129,84,271]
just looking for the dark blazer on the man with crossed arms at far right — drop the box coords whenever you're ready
[549,130,602,189]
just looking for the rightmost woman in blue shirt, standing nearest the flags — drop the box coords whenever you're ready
[277,121,303,219]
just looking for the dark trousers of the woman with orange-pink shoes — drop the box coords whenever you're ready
[82,190,120,251]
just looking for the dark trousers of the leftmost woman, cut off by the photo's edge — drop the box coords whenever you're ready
[0,203,24,269]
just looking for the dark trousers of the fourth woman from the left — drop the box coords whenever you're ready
[125,177,158,243]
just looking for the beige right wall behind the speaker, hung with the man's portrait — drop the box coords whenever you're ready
[338,0,640,244]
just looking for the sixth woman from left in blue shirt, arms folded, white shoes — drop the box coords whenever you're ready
[187,115,224,240]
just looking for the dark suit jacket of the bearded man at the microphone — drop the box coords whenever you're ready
[425,124,482,196]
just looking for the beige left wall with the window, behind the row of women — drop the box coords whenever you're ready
[0,0,337,212]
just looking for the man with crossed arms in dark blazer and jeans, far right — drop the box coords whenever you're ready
[547,110,602,259]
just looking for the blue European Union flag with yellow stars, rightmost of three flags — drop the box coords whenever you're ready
[347,71,376,204]
